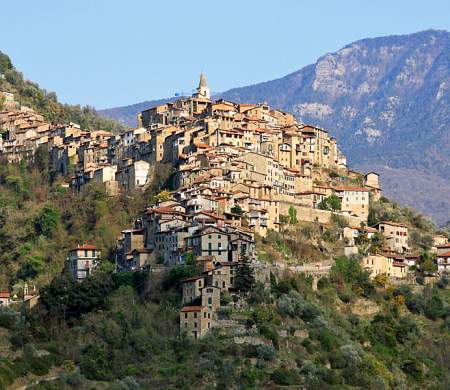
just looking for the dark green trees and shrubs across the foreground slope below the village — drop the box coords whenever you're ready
[0,207,450,389]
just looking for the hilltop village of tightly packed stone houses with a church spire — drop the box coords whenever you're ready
[0,74,450,338]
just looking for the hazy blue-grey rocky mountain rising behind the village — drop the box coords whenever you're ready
[97,30,450,224]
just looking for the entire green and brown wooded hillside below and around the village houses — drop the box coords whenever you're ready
[0,149,450,389]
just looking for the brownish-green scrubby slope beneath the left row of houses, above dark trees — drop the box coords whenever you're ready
[0,159,150,289]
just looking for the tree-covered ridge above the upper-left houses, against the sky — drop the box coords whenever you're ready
[0,52,126,133]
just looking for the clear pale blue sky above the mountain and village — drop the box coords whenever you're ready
[0,0,450,108]
